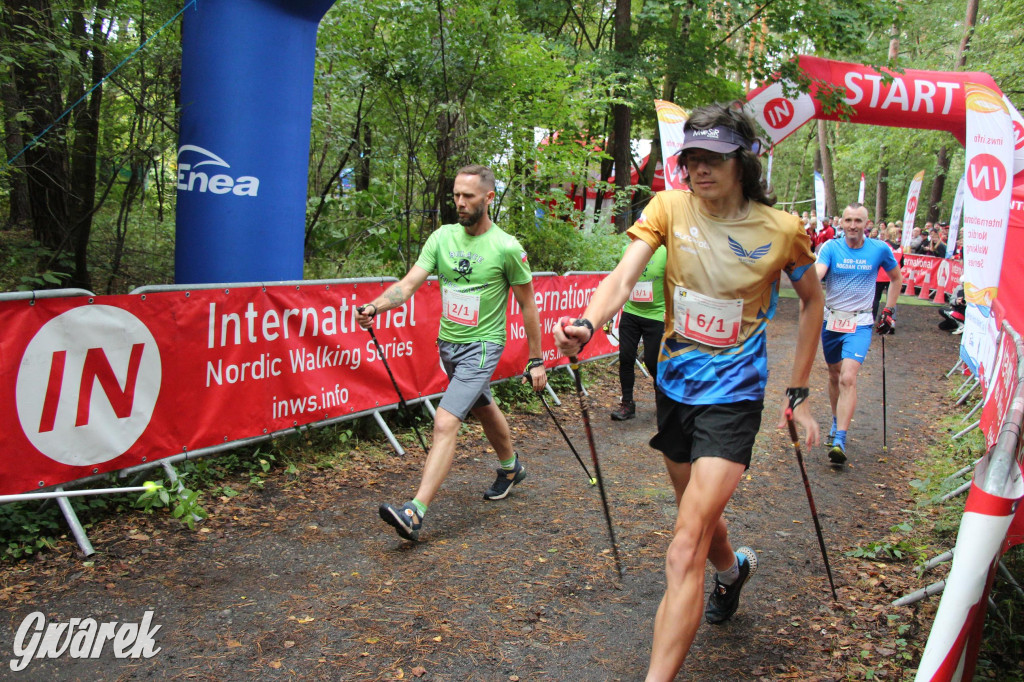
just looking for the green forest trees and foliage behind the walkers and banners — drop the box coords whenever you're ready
[0,0,1024,294]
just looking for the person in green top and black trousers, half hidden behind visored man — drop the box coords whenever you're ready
[611,245,666,422]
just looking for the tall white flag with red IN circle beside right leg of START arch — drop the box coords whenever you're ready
[961,83,1015,376]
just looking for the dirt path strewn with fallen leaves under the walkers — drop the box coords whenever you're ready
[0,299,958,681]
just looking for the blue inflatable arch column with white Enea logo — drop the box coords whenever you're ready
[174,0,334,284]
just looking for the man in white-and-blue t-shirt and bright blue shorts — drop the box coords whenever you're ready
[814,203,903,464]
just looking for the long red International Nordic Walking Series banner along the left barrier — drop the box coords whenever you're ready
[0,274,615,495]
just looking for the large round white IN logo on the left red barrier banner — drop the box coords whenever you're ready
[15,305,162,466]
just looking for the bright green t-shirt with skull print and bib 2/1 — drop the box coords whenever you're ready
[416,224,534,345]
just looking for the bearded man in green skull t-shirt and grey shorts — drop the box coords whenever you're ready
[356,165,548,541]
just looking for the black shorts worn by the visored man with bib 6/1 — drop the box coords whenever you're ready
[650,391,764,467]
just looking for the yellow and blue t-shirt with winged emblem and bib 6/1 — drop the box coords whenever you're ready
[628,189,814,404]
